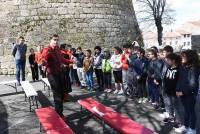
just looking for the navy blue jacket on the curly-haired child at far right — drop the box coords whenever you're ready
[176,67,199,95]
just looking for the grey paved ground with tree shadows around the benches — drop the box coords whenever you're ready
[0,76,177,134]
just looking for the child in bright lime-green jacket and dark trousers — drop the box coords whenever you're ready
[101,50,112,93]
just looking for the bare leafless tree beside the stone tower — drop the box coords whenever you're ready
[136,0,174,46]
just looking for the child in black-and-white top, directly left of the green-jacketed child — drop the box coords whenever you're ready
[94,46,103,91]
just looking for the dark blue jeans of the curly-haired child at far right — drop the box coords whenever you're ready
[181,95,196,129]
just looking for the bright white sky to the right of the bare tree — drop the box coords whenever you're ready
[133,0,200,29]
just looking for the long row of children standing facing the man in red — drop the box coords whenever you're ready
[29,43,200,134]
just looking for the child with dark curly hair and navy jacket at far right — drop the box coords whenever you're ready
[175,50,199,134]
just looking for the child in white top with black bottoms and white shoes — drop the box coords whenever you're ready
[111,47,124,95]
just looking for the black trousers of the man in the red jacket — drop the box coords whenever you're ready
[47,73,65,116]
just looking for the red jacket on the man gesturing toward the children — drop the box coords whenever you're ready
[41,46,72,74]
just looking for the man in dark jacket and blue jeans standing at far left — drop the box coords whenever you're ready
[12,36,27,86]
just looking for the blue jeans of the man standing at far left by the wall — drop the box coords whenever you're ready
[15,60,26,82]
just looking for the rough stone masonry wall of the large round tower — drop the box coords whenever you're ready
[0,0,139,74]
